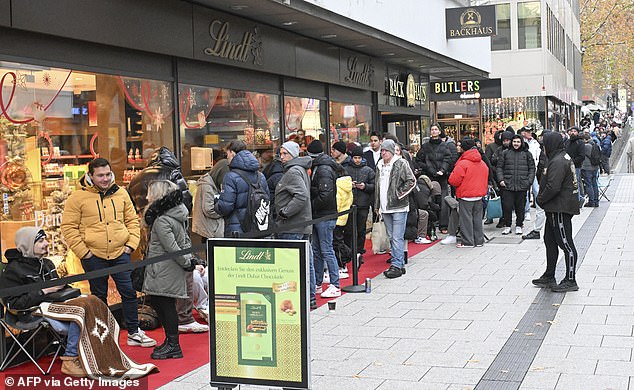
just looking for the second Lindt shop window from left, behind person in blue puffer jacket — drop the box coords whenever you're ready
[178,84,280,176]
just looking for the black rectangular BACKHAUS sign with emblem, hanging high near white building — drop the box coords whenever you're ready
[445,5,497,39]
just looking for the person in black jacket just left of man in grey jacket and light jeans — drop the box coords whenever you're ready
[344,146,375,254]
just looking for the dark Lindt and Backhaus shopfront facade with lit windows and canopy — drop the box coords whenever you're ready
[0,0,490,258]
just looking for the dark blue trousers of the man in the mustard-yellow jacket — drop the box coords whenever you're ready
[81,253,139,334]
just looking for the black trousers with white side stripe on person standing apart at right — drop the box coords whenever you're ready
[544,212,577,280]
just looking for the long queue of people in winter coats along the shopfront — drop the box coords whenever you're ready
[0,119,609,377]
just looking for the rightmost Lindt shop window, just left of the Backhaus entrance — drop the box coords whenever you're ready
[324,102,372,146]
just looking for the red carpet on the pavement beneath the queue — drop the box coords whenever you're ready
[2,240,438,389]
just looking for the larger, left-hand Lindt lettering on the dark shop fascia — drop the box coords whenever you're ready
[204,20,262,65]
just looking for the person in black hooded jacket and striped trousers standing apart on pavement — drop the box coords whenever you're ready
[532,132,579,292]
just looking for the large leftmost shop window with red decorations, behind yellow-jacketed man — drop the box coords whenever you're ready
[0,62,173,261]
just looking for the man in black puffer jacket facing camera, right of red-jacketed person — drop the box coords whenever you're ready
[496,135,535,234]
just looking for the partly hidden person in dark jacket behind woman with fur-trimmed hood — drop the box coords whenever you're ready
[128,146,192,212]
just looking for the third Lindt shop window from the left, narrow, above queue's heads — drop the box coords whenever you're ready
[284,96,328,152]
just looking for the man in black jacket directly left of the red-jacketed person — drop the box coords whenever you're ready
[414,124,451,233]
